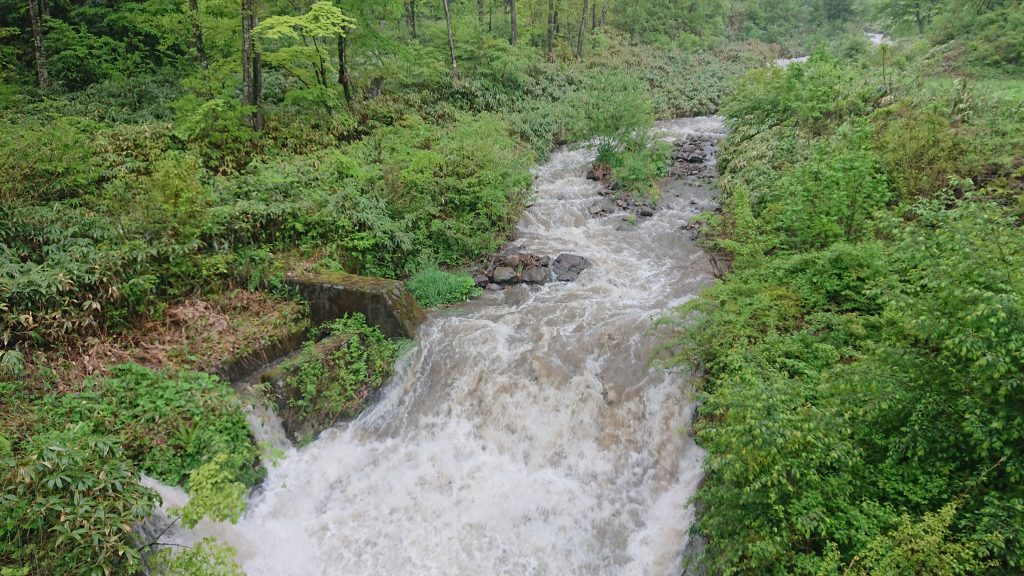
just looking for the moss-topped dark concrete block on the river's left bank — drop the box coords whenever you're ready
[285,273,426,338]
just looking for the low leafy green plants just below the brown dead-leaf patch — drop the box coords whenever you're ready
[44,364,261,485]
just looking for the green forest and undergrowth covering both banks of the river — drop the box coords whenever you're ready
[0,0,1024,576]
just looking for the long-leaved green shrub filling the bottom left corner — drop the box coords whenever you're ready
[0,423,158,574]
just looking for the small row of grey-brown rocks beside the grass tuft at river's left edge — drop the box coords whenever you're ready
[473,250,591,290]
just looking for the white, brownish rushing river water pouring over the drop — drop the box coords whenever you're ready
[149,117,724,576]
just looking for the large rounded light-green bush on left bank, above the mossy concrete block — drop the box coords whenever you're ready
[349,115,530,275]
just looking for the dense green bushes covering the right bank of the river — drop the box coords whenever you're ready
[673,51,1024,575]
